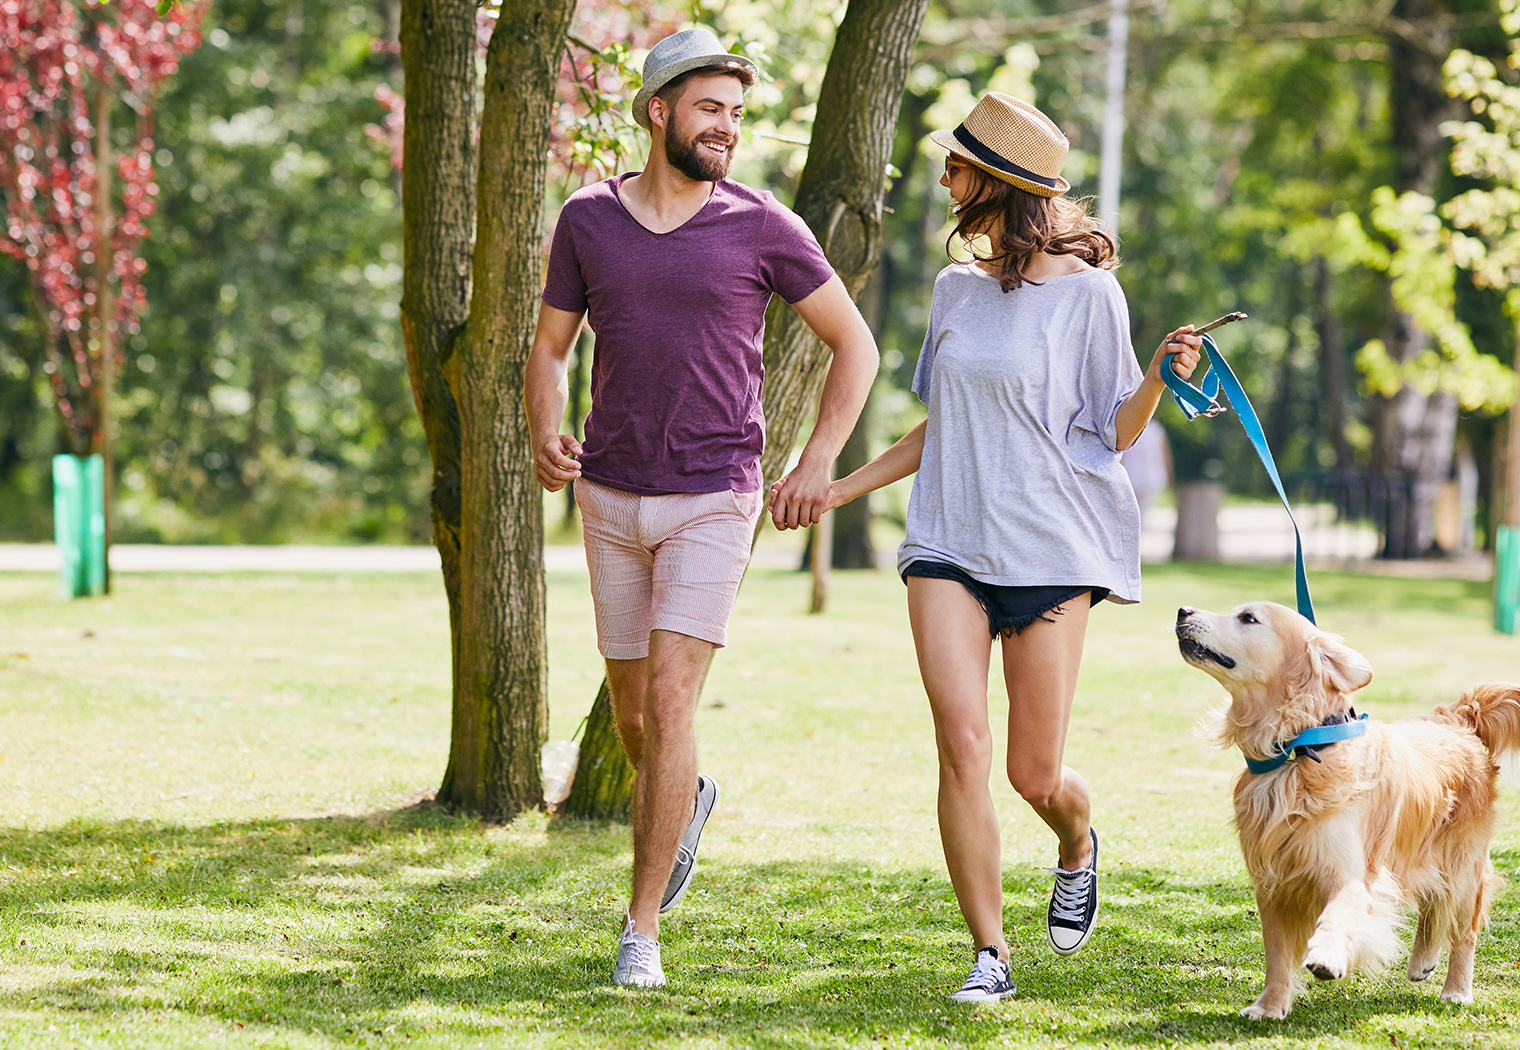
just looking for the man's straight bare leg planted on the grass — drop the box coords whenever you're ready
[623,631,714,941]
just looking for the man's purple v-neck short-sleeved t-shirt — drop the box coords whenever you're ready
[543,175,834,495]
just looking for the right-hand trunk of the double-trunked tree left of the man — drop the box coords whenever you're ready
[438,0,575,821]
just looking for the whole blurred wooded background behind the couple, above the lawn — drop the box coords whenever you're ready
[0,0,1520,567]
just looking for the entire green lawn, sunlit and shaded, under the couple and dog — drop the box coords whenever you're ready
[0,567,1520,1050]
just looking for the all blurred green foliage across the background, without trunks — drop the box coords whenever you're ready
[0,0,1520,539]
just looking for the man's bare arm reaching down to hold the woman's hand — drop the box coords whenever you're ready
[771,274,879,529]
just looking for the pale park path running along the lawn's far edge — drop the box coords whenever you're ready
[0,503,1493,579]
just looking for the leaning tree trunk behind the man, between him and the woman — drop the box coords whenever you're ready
[565,0,929,818]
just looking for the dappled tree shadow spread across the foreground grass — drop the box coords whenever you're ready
[0,808,1520,1047]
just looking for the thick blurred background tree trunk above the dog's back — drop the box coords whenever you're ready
[1373,0,1458,558]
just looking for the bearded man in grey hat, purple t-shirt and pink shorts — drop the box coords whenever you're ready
[526,29,877,988]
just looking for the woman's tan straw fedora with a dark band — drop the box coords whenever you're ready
[929,91,1072,198]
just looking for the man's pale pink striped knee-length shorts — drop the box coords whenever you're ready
[575,477,760,659]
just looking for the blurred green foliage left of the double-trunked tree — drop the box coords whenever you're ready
[0,0,429,542]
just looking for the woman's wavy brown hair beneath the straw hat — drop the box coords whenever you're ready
[945,164,1119,292]
